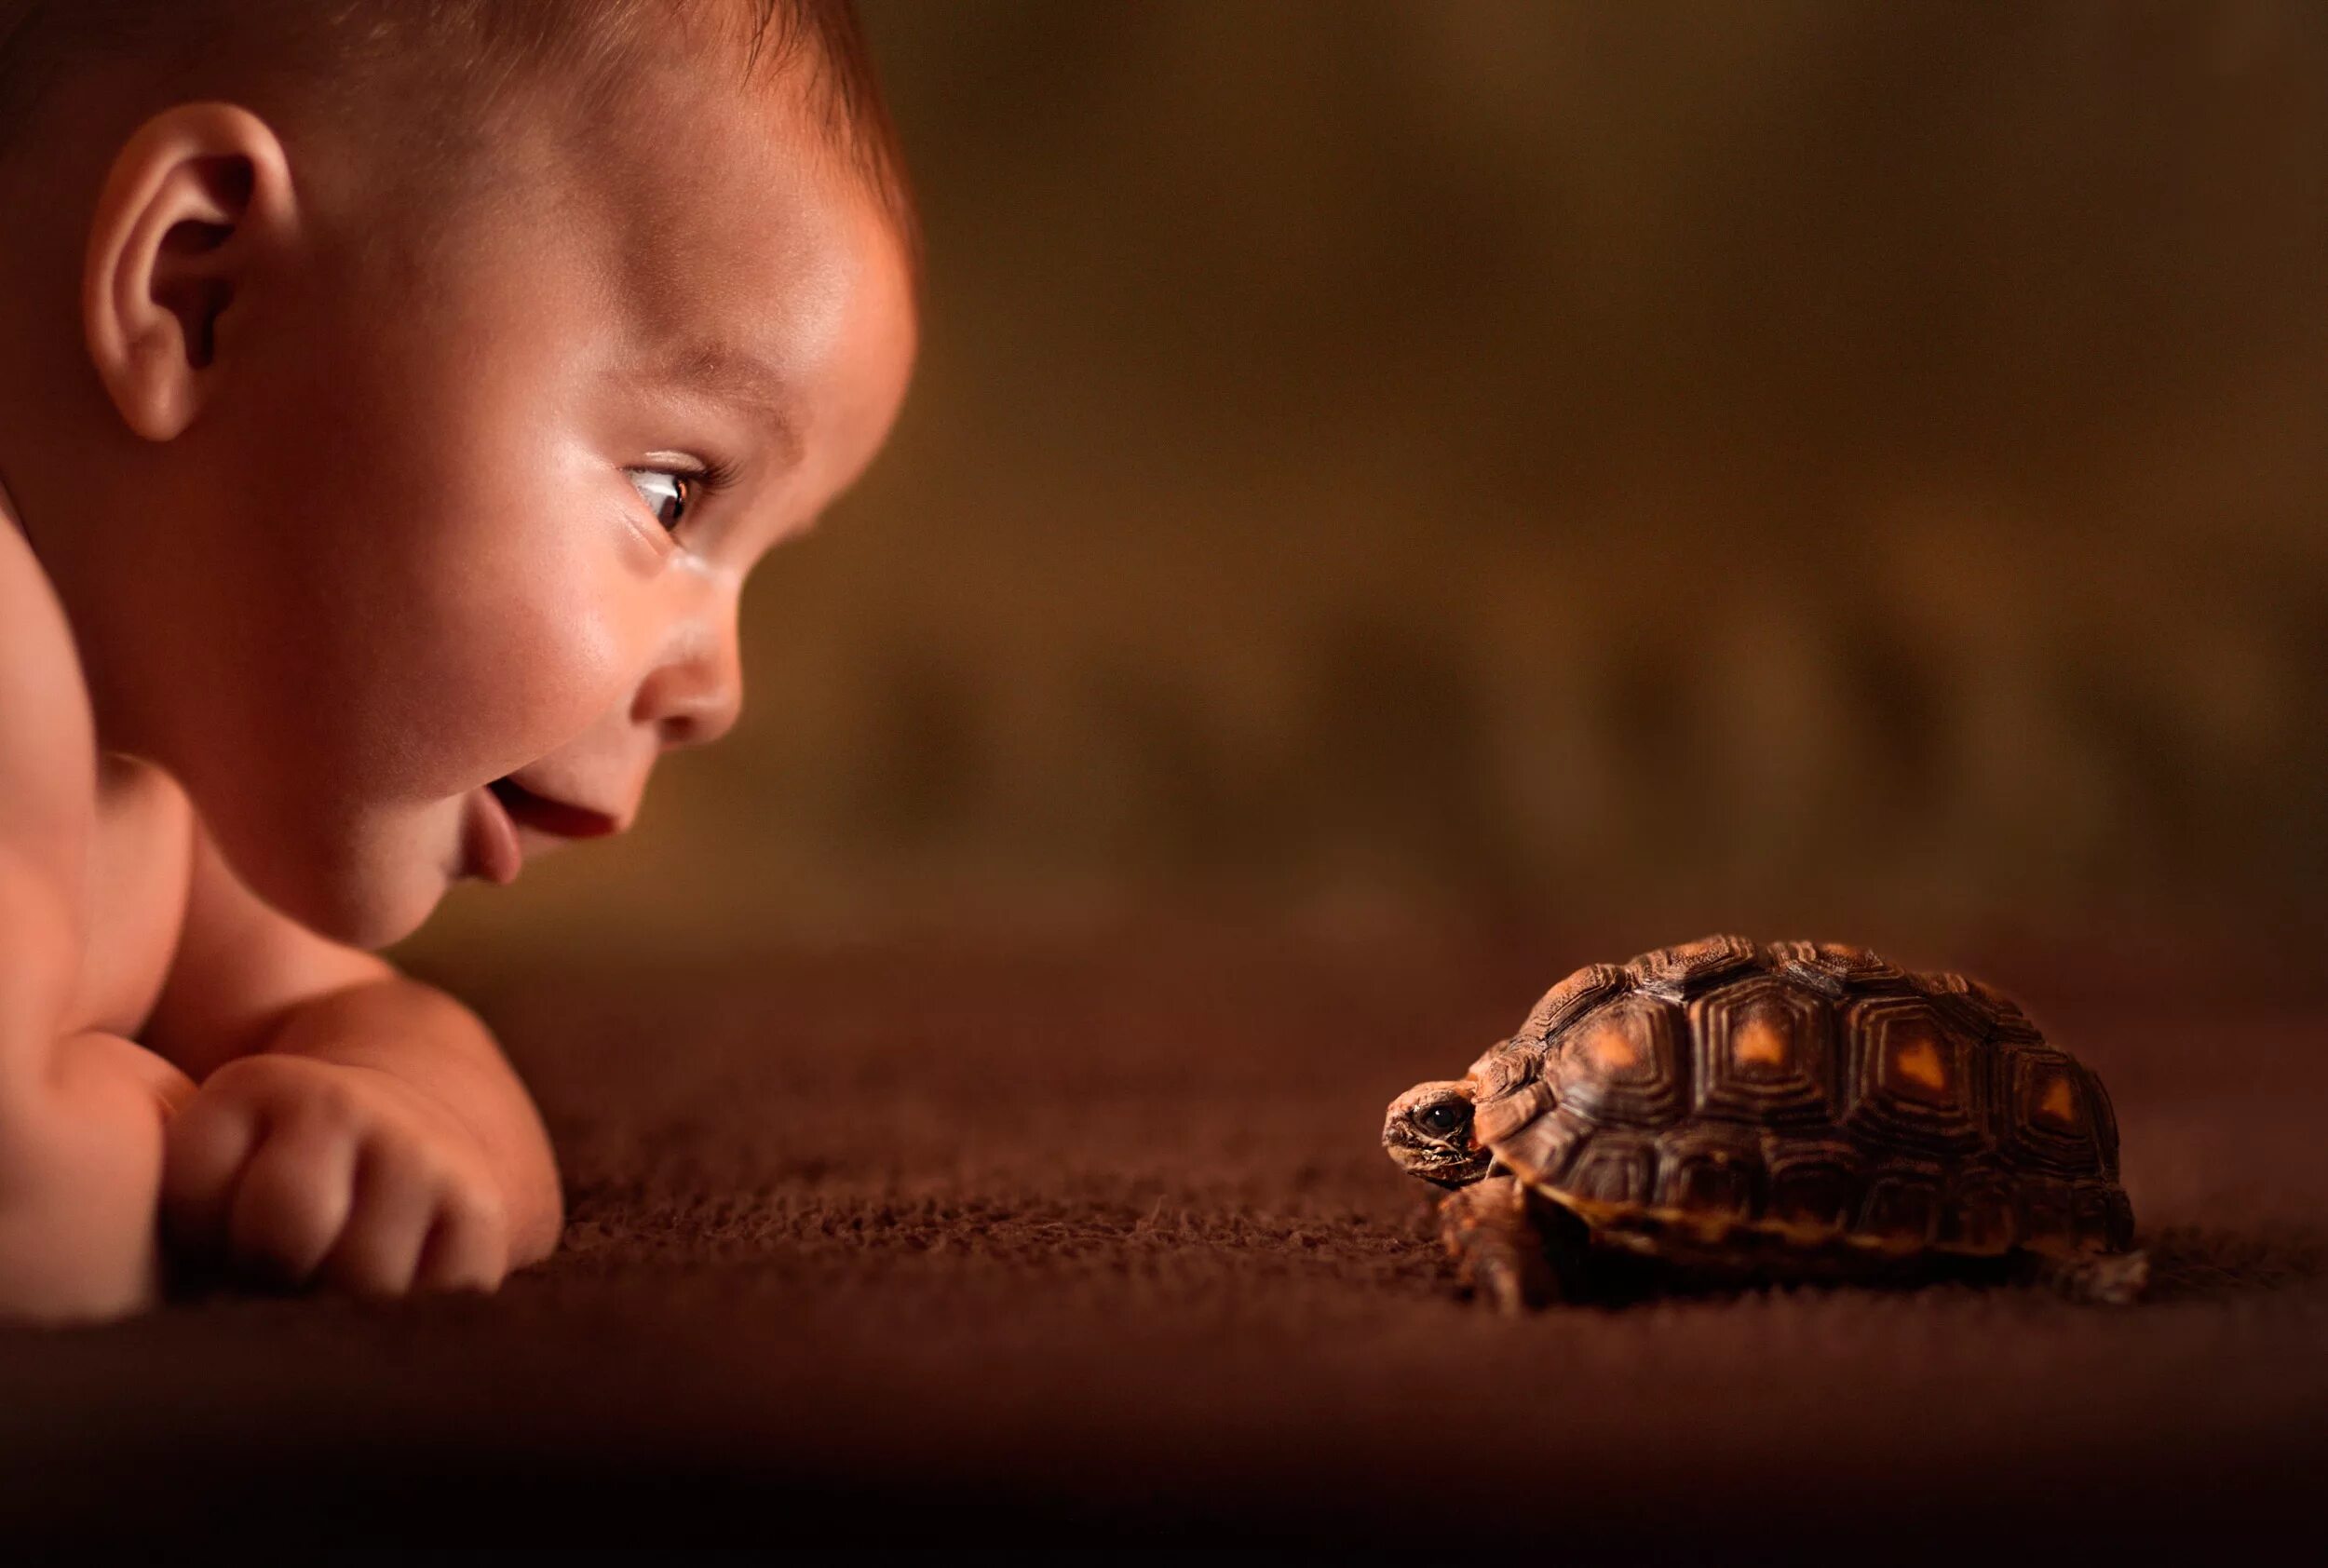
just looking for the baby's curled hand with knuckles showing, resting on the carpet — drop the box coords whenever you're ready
[163,1054,510,1296]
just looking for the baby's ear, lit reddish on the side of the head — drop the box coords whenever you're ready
[82,102,298,442]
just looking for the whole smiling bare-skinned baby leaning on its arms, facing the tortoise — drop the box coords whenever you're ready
[0,0,917,1321]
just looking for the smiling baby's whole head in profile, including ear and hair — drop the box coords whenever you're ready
[0,0,915,947]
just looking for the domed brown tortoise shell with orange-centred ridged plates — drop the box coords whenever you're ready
[1467,938,2132,1256]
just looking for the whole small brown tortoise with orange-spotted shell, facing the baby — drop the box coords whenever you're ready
[1383,935,2149,1310]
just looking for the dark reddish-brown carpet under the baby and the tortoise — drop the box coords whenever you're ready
[0,938,2328,1561]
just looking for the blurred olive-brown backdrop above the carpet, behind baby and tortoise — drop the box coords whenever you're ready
[396,0,2328,961]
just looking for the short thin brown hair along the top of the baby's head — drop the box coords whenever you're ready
[0,0,920,267]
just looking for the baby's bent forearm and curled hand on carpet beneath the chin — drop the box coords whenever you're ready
[147,832,562,1296]
